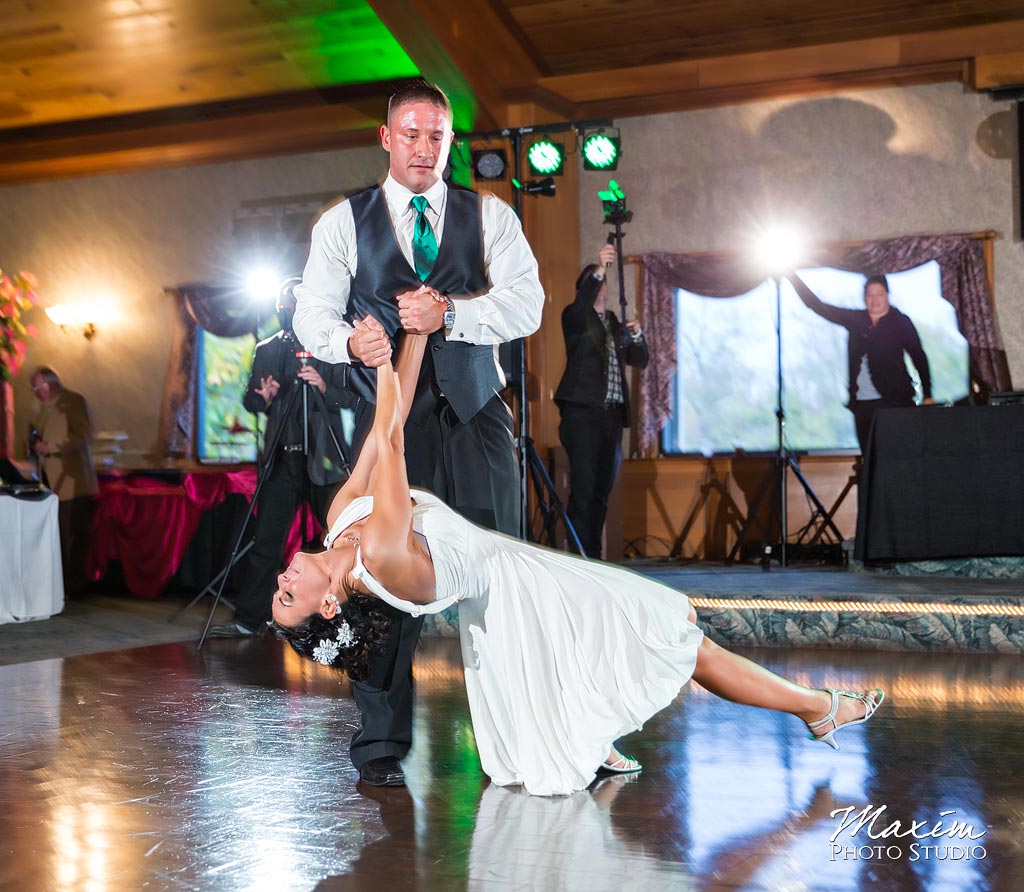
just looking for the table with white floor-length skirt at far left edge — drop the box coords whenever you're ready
[0,493,65,623]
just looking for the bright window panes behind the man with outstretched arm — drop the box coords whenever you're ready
[662,261,969,455]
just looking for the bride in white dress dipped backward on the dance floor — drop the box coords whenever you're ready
[270,317,885,796]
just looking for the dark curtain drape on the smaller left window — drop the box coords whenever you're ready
[152,285,259,464]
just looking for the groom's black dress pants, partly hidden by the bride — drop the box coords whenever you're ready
[351,396,519,768]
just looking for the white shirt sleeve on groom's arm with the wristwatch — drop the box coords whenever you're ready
[446,195,544,344]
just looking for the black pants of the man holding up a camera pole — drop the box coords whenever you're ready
[558,402,623,558]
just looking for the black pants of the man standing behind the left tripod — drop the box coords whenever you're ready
[234,450,340,631]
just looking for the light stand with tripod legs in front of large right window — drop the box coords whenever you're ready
[726,275,843,569]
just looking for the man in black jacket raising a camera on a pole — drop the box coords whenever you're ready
[555,245,648,558]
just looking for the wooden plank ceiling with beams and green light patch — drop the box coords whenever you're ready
[0,0,1024,183]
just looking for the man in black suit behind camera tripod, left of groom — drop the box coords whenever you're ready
[210,279,358,638]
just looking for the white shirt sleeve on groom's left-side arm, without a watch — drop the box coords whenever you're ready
[292,202,356,363]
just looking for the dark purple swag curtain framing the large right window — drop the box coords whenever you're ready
[637,236,1011,454]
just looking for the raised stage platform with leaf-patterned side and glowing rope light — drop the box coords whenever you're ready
[424,558,1024,654]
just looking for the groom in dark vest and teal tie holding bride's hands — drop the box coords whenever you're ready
[293,82,544,787]
